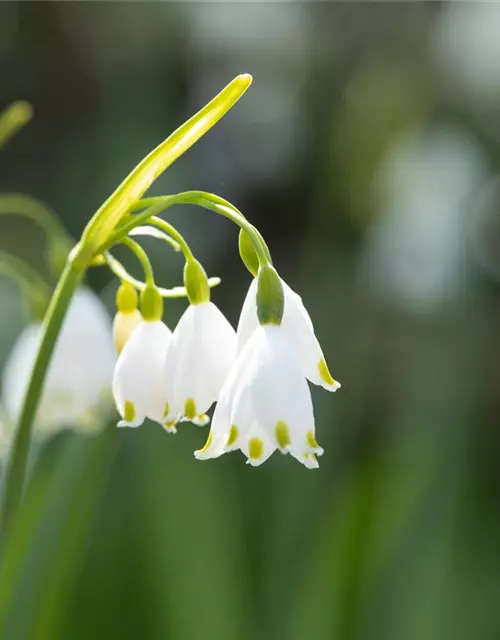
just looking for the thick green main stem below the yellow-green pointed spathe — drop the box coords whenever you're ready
[0,262,84,544]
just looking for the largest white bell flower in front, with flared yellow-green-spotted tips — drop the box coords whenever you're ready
[195,324,323,469]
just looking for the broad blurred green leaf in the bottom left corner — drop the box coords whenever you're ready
[0,432,114,640]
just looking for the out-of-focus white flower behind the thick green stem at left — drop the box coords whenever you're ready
[2,288,116,437]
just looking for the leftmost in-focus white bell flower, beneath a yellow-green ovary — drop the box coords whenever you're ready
[113,321,172,426]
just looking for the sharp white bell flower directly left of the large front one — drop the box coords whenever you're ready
[165,301,236,425]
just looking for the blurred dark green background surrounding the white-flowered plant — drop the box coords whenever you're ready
[0,0,500,640]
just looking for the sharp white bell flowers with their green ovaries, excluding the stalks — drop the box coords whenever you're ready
[113,265,340,468]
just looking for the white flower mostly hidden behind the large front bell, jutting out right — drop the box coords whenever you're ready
[237,278,340,391]
